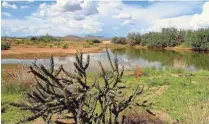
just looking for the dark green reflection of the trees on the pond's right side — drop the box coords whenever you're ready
[111,47,209,70]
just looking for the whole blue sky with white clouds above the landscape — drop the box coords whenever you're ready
[1,0,209,37]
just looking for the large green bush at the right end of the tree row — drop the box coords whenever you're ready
[185,28,209,50]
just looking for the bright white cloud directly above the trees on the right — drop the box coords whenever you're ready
[140,2,209,33]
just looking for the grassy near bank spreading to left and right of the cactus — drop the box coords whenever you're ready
[2,66,209,124]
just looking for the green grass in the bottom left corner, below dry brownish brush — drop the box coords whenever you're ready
[1,83,30,124]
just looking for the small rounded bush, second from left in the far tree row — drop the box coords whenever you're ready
[127,32,141,46]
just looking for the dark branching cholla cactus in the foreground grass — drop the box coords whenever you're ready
[11,49,149,124]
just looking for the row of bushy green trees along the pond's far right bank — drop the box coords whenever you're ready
[111,28,209,50]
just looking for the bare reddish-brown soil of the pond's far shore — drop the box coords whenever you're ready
[1,43,207,59]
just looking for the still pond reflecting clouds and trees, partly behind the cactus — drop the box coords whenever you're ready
[1,48,209,72]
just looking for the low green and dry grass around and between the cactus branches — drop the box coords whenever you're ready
[2,51,209,124]
